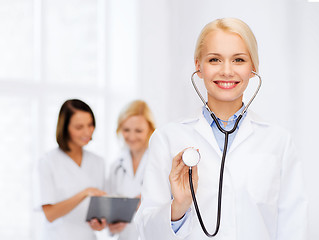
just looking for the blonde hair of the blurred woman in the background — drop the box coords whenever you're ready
[116,100,156,141]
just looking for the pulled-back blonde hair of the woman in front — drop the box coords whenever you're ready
[194,18,259,73]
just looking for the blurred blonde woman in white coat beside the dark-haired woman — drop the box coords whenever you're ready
[107,100,155,240]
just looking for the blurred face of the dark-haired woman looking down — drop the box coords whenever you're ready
[68,110,94,148]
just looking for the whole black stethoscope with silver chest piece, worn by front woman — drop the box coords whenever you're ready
[182,70,262,237]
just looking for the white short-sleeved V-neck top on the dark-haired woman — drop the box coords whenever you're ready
[35,148,105,240]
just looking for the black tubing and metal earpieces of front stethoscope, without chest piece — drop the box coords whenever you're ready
[188,70,262,237]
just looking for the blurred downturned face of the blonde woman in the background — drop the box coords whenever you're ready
[121,116,150,151]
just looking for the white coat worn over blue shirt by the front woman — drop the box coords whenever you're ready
[136,111,307,240]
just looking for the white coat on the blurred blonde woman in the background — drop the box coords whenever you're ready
[107,147,147,240]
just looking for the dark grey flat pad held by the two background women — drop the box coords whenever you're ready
[86,196,140,223]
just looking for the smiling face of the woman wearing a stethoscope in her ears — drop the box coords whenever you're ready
[196,30,253,106]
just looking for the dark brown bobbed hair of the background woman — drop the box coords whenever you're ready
[56,99,95,152]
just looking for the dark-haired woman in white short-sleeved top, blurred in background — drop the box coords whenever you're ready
[35,99,106,240]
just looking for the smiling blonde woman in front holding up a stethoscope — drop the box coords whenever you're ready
[136,18,307,240]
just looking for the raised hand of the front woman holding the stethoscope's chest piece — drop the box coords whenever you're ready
[169,149,198,221]
